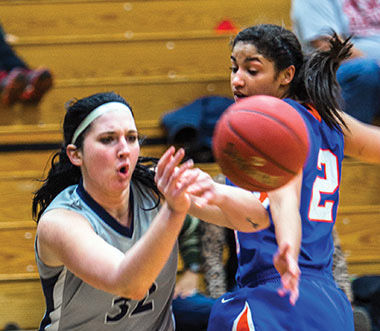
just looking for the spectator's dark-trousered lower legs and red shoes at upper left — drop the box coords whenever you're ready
[0,26,53,106]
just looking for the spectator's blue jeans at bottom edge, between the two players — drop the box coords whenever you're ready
[172,293,216,331]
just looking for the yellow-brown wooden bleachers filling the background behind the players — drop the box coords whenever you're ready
[0,0,380,330]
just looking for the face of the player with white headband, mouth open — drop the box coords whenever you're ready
[81,109,140,192]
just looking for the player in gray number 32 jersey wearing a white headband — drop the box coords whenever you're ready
[33,93,196,331]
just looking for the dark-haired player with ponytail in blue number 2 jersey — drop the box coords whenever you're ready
[157,25,380,331]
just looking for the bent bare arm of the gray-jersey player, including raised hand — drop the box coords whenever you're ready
[37,150,197,299]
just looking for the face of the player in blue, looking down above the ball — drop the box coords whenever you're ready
[231,42,285,101]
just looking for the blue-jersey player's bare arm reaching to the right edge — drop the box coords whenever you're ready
[342,113,380,163]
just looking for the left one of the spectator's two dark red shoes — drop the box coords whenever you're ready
[0,68,27,106]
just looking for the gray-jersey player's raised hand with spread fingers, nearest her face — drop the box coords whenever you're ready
[154,147,197,213]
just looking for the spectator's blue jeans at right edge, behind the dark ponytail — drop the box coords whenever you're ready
[337,58,380,123]
